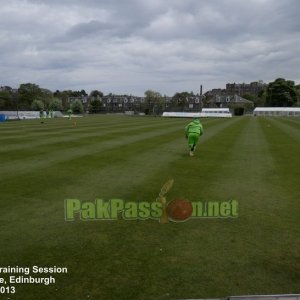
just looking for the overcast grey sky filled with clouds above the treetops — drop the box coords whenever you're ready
[0,0,300,96]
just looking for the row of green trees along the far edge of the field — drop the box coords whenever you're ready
[0,78,300,114]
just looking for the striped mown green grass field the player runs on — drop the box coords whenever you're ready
[0,116,300,300]
